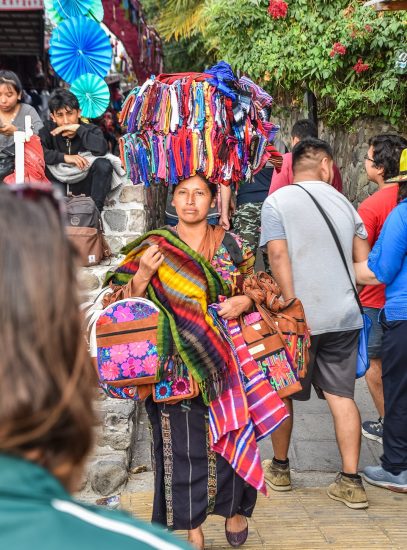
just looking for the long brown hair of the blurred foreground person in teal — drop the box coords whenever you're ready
[0,188,96,489]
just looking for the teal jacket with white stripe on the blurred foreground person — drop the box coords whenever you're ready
[0,454,190,550]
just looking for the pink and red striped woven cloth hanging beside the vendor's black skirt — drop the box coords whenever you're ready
[209,305,289,494]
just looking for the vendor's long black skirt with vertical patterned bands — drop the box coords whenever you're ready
[145,396,257,530]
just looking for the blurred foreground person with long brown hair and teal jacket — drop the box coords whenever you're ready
[0,185,188,550]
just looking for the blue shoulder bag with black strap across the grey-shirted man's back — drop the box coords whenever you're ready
[296,184,372,378]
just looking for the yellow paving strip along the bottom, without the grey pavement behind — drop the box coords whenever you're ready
[122,488,407,550]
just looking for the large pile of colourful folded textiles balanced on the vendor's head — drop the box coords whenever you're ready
[120,61,282,186]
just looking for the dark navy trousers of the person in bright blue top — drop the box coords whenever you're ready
[381,314,407,475]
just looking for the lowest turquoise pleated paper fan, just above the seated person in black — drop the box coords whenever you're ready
[71,73,110,118]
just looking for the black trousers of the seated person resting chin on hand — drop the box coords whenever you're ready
[47,158,113,212]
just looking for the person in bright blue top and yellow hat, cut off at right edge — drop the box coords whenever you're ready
[355,149,407,493]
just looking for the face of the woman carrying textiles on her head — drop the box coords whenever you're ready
[171,176,215,224]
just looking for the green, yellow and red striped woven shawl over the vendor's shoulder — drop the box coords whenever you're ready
[105,229,233,404]
